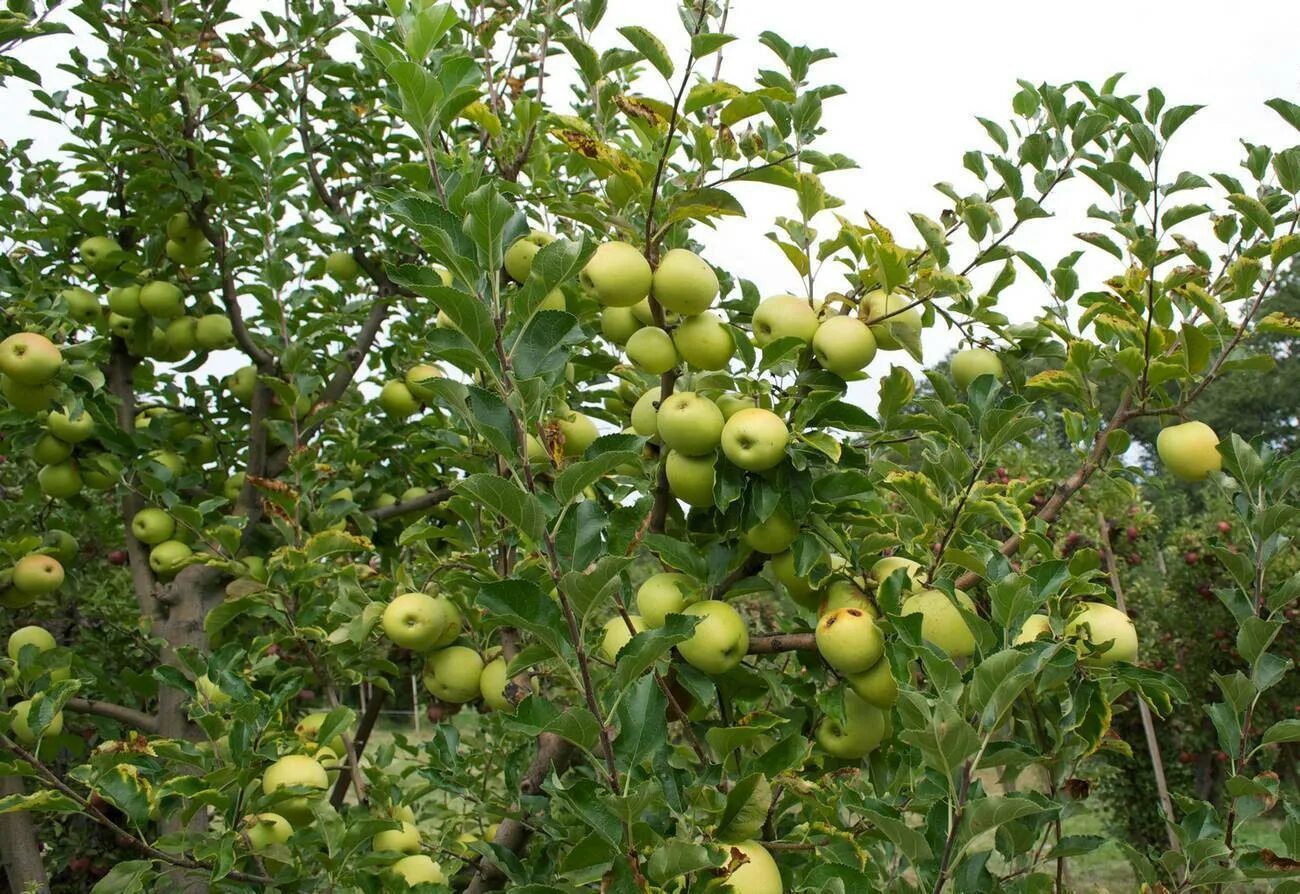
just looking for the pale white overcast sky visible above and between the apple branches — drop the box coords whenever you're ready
[0,0,1300,403]
